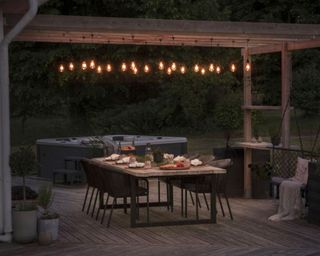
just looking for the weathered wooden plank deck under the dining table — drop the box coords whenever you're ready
[0,177,320,256]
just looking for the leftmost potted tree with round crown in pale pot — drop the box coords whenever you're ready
[9,147,37,243]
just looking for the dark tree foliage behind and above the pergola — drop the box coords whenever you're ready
[10,0,320,134]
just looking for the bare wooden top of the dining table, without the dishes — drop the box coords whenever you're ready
[92,157,227,178]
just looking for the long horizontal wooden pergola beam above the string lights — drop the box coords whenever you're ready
[5,15,320,47]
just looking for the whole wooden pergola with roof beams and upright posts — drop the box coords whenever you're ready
[0,0,320,240]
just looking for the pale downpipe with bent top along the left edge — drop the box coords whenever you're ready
[0,0,39,241]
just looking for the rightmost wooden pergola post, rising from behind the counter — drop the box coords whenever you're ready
[281,44,292,148]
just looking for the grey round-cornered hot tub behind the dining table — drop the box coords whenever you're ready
[36,134,188,179]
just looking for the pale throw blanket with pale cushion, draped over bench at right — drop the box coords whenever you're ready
[269,157,309,221]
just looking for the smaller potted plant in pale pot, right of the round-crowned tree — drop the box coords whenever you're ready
[38,186,59,245]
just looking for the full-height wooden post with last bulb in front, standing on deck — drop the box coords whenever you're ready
[243,48,252,198]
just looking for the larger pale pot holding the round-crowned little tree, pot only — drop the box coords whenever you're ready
[12,210,37,243]
